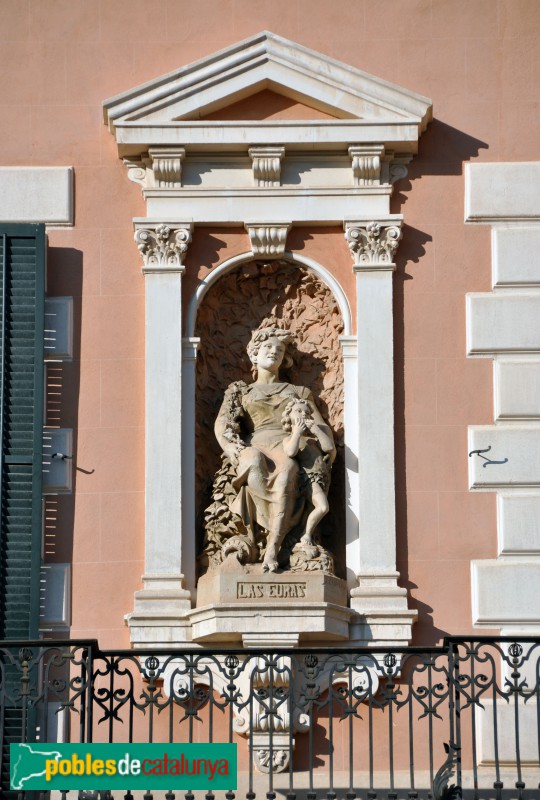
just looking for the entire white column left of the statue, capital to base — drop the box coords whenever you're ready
[127,220,194,647]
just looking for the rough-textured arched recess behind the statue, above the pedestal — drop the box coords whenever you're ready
[195,254,350,577]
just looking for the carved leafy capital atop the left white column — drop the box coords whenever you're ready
[135,223,192,272]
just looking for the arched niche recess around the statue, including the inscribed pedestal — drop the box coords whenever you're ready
[193,259,351,643]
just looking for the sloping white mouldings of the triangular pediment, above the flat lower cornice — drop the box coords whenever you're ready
[104,32,431,145]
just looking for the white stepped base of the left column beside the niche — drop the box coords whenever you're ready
[125,575,191,649]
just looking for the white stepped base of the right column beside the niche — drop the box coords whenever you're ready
[350,572,418,647]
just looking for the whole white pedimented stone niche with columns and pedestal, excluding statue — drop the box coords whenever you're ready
[104,32,431,648]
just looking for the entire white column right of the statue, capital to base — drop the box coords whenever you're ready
[345,222,416,644]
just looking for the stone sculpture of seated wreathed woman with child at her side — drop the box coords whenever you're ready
[209,327,336,572]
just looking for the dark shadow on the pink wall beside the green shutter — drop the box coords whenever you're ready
[43,247,86,637]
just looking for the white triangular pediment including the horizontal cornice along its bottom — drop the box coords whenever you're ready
[104,31,432,157]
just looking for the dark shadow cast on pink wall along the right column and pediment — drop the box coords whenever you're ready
[392,119,489,645]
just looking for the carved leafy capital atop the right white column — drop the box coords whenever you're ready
[345,220,401,270]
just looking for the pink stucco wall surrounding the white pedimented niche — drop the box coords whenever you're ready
[0,0,540,647]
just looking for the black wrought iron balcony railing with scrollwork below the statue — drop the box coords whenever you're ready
[0,637,540,800]
